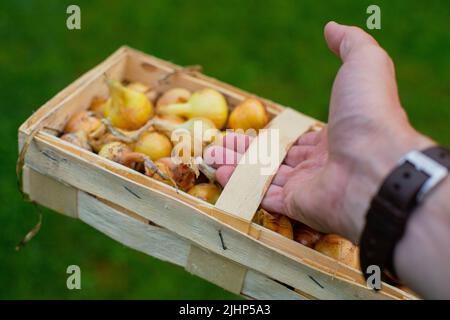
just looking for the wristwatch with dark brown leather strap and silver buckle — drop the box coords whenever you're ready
[360,146,450,289]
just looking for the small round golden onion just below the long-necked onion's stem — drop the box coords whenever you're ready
[134,131,172,161]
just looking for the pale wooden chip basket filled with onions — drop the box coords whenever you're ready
[19,47,415,299]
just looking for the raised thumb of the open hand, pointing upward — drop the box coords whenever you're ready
[324,22,407,129]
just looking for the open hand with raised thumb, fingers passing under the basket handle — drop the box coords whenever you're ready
[205,22,432,243]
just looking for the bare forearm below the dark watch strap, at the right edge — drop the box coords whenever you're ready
[394,177,450,299]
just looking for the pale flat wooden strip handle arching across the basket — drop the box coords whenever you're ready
[215,108,319,222]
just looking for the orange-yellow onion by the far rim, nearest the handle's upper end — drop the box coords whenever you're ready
[228,98,269,131]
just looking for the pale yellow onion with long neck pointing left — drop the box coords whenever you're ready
[158,88,228,129]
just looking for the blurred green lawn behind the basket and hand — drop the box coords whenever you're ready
[0,0,450,299]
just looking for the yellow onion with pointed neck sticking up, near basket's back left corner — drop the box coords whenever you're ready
[104,80,153,130]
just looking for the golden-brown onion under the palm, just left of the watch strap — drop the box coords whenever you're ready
[314,234,359,269]
